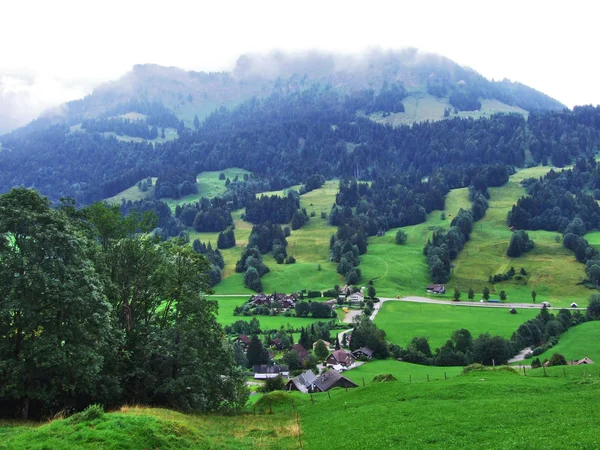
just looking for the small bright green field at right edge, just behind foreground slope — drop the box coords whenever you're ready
[524,321,600,364]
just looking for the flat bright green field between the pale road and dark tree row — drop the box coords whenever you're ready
[375,301,539,351]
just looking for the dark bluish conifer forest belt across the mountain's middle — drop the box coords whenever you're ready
[0,84,600,204]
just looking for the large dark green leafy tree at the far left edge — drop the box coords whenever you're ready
[0,188,112,419]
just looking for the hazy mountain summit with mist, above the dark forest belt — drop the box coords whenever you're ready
[4,49,564,138]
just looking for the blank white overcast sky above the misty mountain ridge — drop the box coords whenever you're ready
[0,0,600,126]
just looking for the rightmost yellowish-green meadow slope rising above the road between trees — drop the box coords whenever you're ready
[447,167,593,306]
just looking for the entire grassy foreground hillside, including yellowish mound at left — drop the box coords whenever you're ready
[0,361,600,449]
